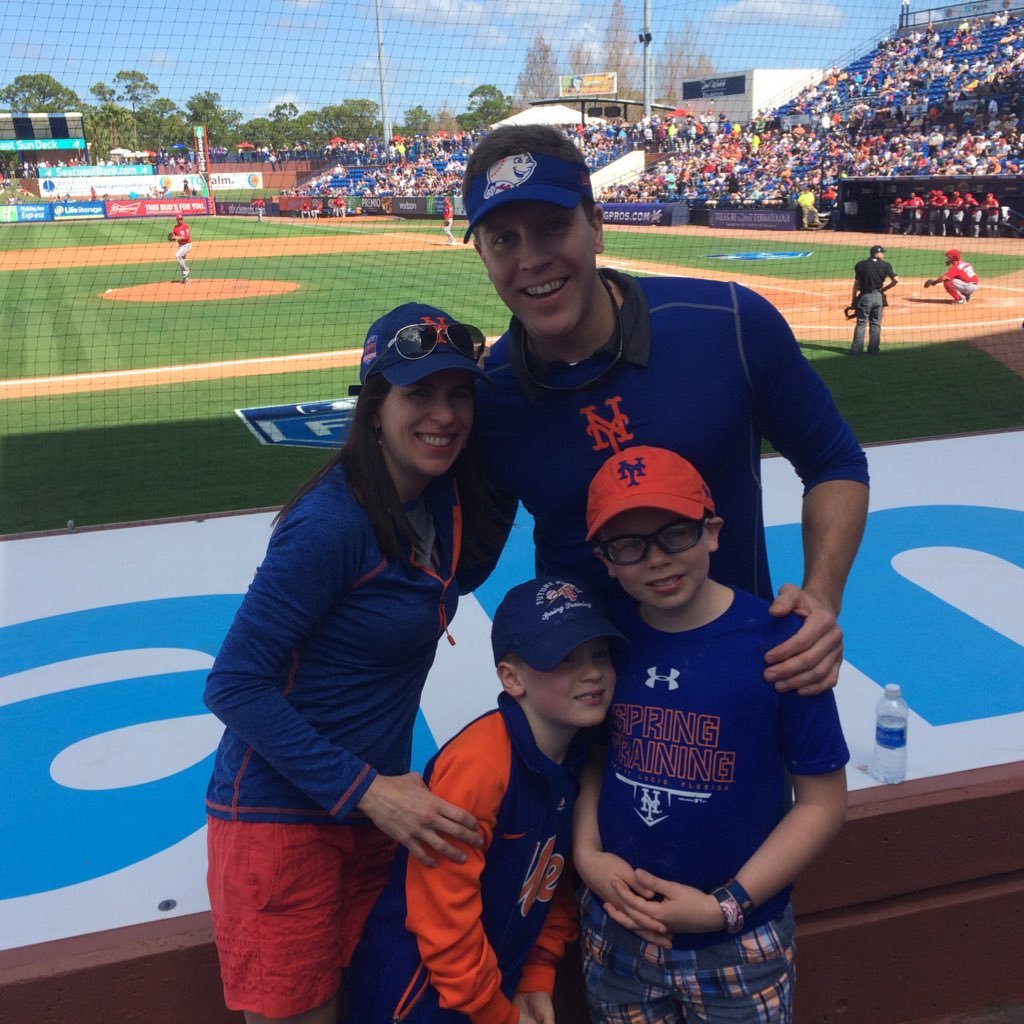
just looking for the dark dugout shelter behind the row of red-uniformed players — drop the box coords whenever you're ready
[839,174,1024,233]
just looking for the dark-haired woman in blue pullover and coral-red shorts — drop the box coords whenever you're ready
[205,304,504,1024]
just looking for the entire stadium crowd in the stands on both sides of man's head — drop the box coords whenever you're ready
[266,12,1024,216]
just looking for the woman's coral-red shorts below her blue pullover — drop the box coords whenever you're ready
[207,818,395,1017]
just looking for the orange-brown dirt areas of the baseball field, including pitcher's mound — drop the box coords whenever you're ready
[0,221,1024,399]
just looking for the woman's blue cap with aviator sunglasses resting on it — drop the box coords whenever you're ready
[349,302,487,393]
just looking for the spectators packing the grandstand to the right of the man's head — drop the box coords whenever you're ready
[601,13,1024,206]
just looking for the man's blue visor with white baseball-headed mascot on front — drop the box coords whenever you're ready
[463,153,594,242]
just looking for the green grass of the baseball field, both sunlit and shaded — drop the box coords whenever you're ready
[0,218,1024,534]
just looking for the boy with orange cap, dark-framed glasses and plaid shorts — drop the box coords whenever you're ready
[573,445,849,1024]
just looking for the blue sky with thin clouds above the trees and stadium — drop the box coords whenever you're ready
[0,0,897,122]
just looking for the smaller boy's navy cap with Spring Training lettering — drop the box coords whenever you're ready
[490,577,623,672]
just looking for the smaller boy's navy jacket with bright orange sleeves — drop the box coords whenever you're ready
[348,694,585,1024]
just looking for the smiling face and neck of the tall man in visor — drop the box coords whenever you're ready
[473,200,614,361]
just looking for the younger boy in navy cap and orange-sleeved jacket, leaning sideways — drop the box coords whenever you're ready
[349,578,621,1024]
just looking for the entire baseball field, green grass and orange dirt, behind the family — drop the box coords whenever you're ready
[0,217,1024,535]
